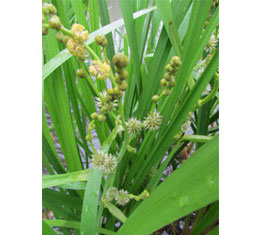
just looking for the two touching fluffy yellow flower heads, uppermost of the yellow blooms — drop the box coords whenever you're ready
[64,24,88,60]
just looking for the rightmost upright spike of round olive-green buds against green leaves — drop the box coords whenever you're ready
[160,56,181,95]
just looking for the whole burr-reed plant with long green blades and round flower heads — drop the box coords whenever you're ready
[42,0,219,235]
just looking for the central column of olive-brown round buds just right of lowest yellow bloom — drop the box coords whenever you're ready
[113,53,128,92]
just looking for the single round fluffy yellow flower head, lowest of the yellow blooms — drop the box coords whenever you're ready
[89,60,111,80]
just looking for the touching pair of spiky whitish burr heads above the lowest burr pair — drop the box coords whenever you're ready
[91,151,117,175]
